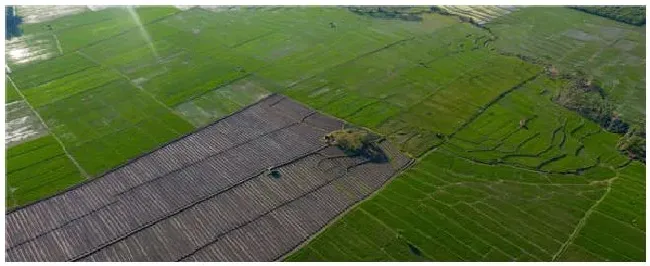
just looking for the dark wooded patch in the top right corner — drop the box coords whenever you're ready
[571,6,645,26]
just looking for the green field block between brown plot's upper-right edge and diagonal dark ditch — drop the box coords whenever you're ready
[280,24,541,156]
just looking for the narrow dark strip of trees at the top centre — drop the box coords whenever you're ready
[348,6,433,21]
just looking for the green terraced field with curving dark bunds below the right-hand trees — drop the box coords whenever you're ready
[447,76,625,173]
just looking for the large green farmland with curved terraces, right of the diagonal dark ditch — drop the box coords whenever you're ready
[287,74,645,261]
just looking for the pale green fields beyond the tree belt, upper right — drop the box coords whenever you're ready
[486,7,646,127]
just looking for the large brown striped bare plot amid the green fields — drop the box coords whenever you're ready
[6,95,409,261]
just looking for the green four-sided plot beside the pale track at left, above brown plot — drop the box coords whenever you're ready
[36,80,194,176]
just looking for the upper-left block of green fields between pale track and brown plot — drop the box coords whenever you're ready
[7,7,457,206]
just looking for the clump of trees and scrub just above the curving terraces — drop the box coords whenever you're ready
[553,72,629,134]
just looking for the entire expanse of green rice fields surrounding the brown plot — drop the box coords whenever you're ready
[5,6,645,261]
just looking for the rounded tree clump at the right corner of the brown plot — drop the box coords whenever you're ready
[323,128,388,162]
